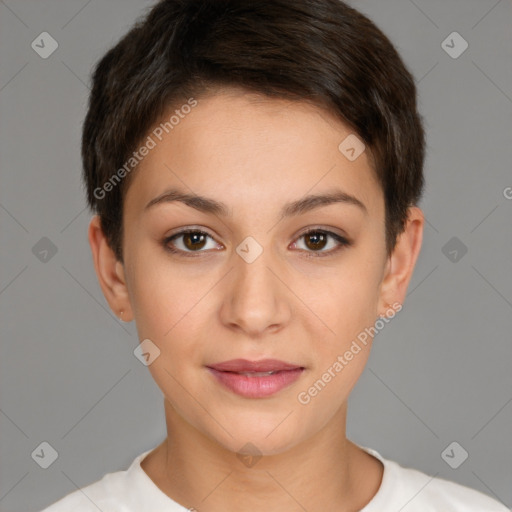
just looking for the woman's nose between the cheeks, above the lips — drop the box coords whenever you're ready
[220,246,291,338]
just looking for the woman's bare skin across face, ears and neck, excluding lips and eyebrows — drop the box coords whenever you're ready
[89,89,424,512]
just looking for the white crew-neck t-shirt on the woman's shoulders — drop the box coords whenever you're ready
[41,446,509,512]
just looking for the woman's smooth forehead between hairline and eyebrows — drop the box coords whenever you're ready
[125,89,382,219]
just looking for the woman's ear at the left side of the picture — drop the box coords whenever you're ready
[88,215,133,322]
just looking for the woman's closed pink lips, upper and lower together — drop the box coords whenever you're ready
[207,359,304,398]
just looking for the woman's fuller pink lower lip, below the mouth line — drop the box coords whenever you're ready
[208,368,303,398]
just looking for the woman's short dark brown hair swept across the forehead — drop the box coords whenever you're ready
[82,0,425,261]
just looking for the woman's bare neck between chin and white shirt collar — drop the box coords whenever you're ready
[142,401,382,512]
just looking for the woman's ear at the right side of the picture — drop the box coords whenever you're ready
[379,206,425,316]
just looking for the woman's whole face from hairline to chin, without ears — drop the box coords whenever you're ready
[119,91,387,454]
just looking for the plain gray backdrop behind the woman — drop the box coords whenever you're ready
[0,0,512,512]
